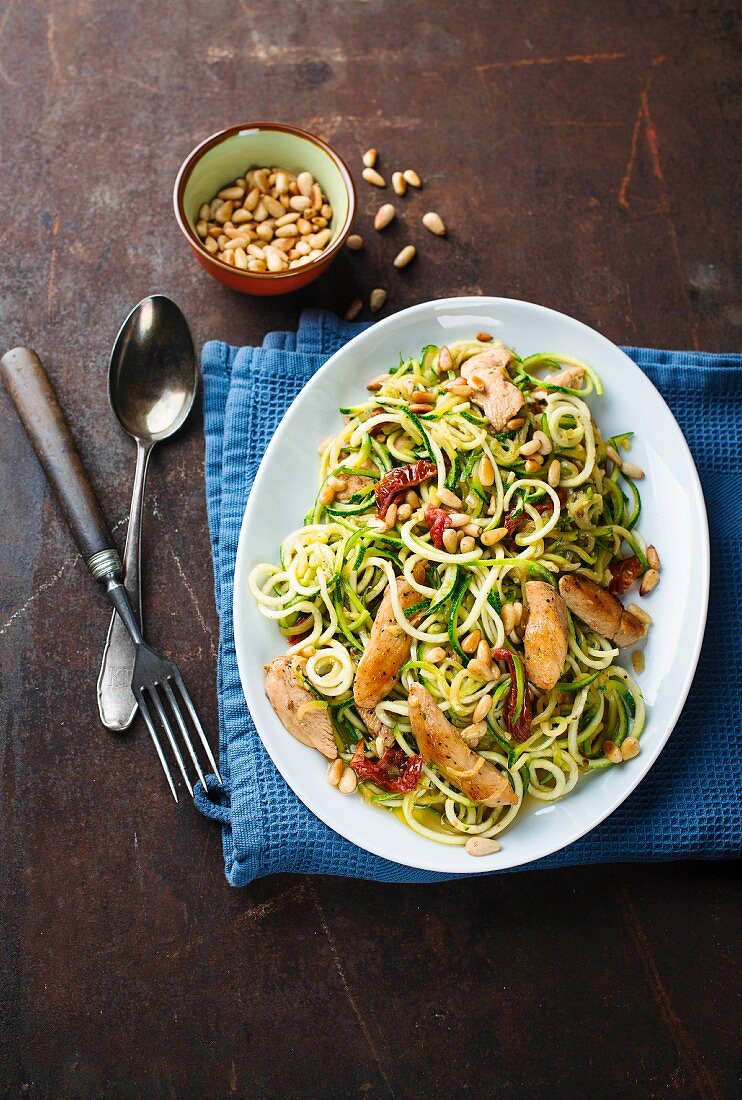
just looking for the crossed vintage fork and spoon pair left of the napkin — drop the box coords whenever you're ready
[0,295,221,802]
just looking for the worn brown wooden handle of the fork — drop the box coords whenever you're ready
[0,348,121,581]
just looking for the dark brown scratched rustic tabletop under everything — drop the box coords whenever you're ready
[0,0,742,1098]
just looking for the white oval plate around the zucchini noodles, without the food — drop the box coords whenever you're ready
[233,297,709,873]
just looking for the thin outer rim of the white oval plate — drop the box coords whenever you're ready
[232,295,710,877]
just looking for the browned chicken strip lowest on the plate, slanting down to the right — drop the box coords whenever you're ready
[409,684,518,806]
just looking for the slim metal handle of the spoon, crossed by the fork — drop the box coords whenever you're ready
[98,441,154,730]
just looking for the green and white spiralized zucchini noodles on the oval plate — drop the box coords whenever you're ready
[248,340,646,845]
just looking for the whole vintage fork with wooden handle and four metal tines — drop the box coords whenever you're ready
[0,348,221,802]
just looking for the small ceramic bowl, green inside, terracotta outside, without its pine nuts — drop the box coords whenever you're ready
[173,122,355,295]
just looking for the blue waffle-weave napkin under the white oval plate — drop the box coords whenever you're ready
[196,310,742,887]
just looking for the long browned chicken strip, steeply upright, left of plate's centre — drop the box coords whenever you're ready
[353,561,425,711]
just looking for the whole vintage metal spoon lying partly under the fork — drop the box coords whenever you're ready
[98,294,198,729]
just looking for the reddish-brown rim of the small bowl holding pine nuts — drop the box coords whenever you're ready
[173,122,356,282]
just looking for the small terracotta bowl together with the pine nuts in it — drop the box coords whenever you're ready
[173,122,356,295]
